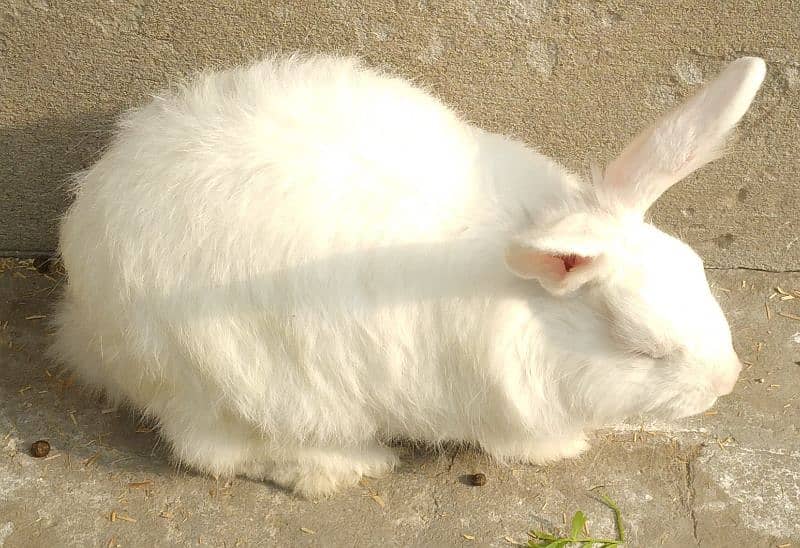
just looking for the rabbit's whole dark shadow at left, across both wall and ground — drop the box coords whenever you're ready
[0,110,180,478]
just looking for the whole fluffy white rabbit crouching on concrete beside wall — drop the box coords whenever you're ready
[53,56,765,496]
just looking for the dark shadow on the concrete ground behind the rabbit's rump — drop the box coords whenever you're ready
[0,263,175,473]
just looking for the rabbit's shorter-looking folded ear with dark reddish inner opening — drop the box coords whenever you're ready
[505,214,613,295]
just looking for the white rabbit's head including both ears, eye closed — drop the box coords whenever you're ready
[506,58,766,419]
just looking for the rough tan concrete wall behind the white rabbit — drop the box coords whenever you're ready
[0,0,800,270]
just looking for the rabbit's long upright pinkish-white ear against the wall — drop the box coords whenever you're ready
[598,57,766,214]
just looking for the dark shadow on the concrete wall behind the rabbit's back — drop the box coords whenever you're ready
[0,112,118,257]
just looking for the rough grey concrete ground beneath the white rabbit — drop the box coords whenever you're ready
[0,259,800,548]
